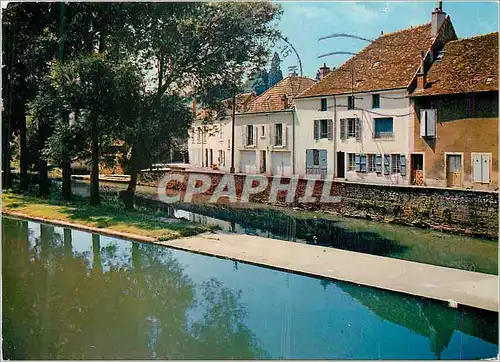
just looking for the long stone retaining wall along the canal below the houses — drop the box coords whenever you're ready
[139,170,498,239]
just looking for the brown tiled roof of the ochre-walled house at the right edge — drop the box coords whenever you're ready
[412,32,498,96]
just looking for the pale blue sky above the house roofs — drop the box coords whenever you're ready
[276,1,498,78]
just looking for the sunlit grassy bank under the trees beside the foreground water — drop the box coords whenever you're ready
[2,192,217,240]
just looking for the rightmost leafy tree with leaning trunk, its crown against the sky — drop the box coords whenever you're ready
[117,2,281,207]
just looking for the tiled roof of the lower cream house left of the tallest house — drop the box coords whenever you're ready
[246,76,315,113]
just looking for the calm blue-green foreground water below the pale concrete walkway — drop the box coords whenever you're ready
[2,217,498,359]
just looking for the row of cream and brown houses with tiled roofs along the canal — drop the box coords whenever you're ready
[188,6,498,189]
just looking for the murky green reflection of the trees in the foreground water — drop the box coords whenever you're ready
[2,218,266,359]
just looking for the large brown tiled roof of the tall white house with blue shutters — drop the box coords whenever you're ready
[299,23,434,98]
